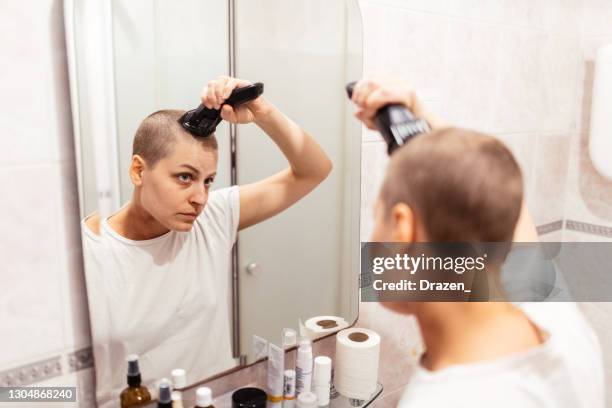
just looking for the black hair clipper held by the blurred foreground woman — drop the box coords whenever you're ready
[346,82,431,155]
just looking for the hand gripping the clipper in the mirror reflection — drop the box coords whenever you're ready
[201,75,271,123]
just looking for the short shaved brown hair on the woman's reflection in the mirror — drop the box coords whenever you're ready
[132,109,217,167]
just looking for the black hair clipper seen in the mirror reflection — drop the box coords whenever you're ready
[179,82,263,137]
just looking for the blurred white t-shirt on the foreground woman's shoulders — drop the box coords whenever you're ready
[398,303,604,408]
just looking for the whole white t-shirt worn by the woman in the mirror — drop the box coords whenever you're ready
[82,186,240,408]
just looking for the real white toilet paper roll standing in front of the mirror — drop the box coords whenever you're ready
[334,328,380,400]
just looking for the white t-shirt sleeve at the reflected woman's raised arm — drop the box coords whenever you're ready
[203,186,240,244]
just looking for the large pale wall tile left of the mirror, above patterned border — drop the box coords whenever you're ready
[0,165,64,368]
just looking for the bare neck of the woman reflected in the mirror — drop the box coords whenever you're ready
[108,192,169,241]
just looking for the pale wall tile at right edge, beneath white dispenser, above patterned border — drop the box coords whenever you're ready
[565,133,612,226]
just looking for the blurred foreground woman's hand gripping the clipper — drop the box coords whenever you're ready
[351,77,447,130]
